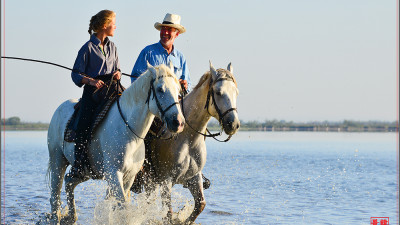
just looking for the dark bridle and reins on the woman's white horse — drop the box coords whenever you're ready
[117,74,179,140]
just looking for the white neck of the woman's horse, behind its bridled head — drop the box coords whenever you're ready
[119,78,154,138]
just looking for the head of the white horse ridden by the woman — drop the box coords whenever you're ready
[147,63,185,133]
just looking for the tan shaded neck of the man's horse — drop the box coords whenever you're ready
[183,85,211,133]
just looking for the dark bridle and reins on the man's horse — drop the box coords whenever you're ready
[181,71,237,142]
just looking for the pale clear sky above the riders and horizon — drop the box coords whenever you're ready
[1,0,398,122]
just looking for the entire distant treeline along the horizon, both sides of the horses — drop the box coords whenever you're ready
[1,117,399,132]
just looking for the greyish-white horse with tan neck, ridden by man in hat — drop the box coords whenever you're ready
[144,62,240,224]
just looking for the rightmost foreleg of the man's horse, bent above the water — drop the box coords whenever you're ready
[185,173,206,224]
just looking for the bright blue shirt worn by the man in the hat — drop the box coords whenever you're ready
[131,42,190,90]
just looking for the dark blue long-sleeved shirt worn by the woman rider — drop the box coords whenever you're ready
[71,34,120,87]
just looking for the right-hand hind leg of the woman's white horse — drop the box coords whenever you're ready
[62,172,89,224]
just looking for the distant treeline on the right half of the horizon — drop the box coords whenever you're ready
[208,120,399,132]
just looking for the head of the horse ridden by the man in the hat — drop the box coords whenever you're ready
[207,62,240,135]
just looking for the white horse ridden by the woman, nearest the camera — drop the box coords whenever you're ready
[48,64,184,224]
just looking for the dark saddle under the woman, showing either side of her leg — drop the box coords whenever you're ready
[64,80,125,143]
